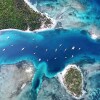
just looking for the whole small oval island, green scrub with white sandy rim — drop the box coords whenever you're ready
[58,65,83,98]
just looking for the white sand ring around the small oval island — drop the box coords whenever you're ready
[56,64,85,99]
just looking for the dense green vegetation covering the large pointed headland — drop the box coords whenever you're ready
[0,0,51,30]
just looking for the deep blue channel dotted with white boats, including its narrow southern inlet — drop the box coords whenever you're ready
[0,29,100,94]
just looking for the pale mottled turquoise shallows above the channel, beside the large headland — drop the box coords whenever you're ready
[30,0,100,30]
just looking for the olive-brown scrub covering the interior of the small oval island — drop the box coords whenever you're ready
[64,67,82,97]
